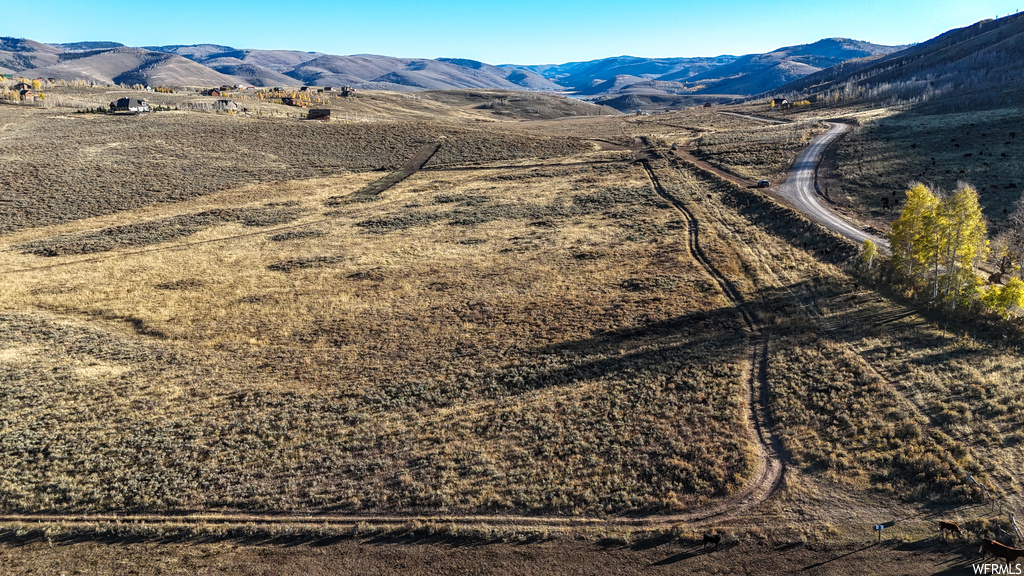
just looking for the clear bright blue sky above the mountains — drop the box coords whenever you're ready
[8,0,1024,64]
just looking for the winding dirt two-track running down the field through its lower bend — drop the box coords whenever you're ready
[639,159,785,524]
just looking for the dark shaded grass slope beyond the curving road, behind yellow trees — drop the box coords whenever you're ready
[765,103,1024,233]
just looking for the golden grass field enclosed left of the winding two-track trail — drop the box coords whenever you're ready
[0,145,752,513]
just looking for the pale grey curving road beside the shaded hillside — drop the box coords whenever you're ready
[777,122,889,251]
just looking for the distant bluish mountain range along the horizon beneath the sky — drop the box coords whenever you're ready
[0,38,899,98]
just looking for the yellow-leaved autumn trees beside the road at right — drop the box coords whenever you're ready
[862,182,1024,320]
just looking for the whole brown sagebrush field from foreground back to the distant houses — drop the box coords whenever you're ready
[0,84,1024,574]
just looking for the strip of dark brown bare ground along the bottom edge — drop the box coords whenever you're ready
[0,533,990,576]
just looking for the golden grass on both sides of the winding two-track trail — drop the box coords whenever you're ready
[0,99,1024,537]
